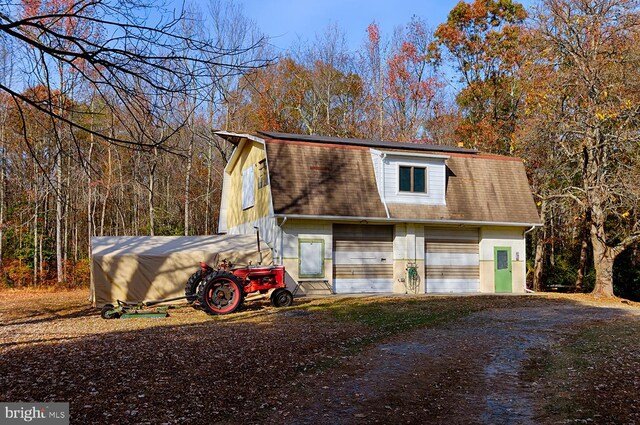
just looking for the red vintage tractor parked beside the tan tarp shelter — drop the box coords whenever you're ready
[184,260,293,314]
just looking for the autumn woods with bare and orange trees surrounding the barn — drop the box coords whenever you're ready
[0,0,640,299]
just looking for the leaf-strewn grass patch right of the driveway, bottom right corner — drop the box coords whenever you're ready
[524,319,640,424]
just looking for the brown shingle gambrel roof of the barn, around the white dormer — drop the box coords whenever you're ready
[261,132,540,224]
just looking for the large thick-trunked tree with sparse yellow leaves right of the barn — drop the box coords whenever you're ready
[525,0,640,296]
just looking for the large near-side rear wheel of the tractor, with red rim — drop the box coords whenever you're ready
[198,271,244,314]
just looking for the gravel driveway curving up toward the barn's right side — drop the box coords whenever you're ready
[282,305,638,424]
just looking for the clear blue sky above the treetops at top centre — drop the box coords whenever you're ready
[237,0,533,50]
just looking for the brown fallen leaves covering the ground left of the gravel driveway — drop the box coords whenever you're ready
[0,291,640,424]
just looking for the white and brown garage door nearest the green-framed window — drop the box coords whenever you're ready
[333,224,393,294]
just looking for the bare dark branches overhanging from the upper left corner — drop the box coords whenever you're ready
[0,0,269,148]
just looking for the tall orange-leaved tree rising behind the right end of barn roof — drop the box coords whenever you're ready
[432,0,527,154]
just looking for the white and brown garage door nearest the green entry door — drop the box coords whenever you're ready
[424,227,480,292]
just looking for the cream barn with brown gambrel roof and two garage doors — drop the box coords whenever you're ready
[217,131,540,293]
